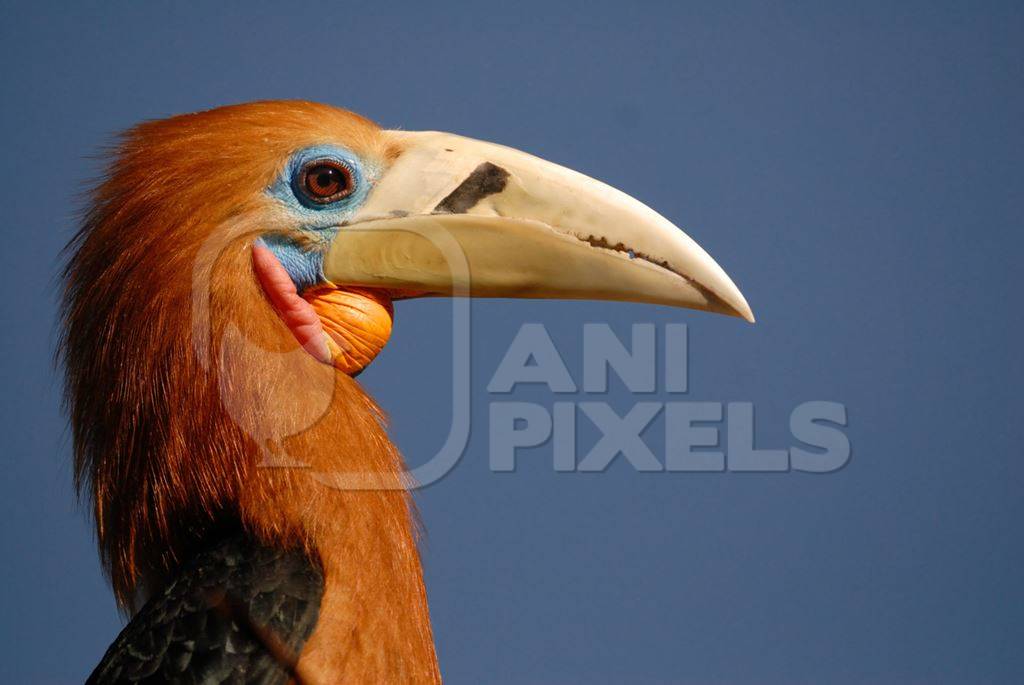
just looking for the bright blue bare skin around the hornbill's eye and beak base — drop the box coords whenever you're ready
[257,145,380,293]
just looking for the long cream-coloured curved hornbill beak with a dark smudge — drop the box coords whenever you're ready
[324,131,754,322]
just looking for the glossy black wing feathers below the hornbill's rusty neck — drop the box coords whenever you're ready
[86,536,324,685]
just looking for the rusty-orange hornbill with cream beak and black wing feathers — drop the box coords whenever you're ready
[59,101,753,683]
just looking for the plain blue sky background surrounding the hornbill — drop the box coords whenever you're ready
[0,2,1024,683]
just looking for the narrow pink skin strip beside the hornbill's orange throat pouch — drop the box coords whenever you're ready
[253,244,331,363]
